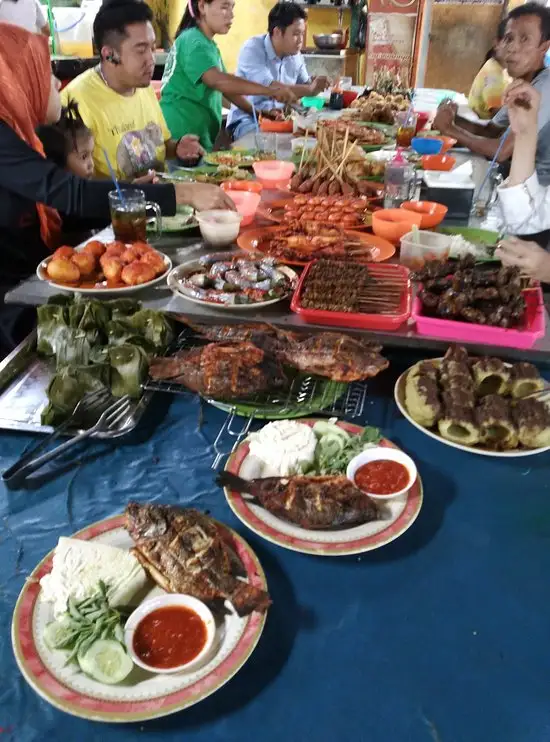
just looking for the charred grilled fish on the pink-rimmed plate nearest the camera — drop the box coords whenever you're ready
[126,502,271,616]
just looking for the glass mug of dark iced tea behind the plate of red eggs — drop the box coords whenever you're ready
[109,188,162,243]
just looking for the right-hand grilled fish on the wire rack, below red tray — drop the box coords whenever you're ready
[276,332,389,382]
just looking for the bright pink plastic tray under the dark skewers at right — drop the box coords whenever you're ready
[411,287,546,348]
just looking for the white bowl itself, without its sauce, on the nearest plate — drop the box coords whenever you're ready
[124,593,216,675]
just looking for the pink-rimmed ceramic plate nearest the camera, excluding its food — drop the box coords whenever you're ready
[12,515,267,722]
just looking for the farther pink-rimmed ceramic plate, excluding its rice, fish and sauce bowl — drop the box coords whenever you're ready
[225,419,423,556]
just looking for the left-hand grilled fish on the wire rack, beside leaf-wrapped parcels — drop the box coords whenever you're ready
[149,342,286,399]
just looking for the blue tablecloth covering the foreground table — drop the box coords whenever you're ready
[0,356,550,742]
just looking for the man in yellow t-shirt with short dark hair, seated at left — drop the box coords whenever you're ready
[62,0,202,180]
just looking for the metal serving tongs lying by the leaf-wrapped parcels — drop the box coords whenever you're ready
[2,389,132,482]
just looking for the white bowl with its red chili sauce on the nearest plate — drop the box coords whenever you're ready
[124,594,216,674]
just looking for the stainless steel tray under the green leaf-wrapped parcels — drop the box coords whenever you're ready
[0,331,152,439]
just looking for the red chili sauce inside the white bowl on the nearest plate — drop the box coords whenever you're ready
[134,606,207,670]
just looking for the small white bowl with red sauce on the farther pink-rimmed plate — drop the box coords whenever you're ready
[346,446,417,500]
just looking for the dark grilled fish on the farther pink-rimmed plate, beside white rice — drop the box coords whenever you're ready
[216,471,378,530]
